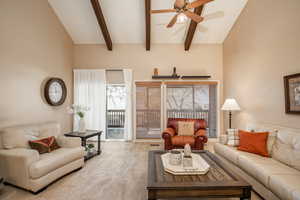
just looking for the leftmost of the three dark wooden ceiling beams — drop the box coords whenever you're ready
[91,0,112,51]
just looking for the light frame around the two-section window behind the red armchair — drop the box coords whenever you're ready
[132,80,223,142]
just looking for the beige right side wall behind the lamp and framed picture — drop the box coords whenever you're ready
[224,0,300,128]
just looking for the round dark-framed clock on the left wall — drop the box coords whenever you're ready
[44,78,67,106]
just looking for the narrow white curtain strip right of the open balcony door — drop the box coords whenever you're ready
[123,69,133,141]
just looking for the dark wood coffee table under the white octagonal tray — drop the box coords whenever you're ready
[147,151,252,200]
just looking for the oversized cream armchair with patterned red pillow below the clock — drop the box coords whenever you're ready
[0,122,85,192]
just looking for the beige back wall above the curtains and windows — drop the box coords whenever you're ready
[74,44,223,134]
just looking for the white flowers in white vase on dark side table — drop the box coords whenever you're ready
[69,104,90,133]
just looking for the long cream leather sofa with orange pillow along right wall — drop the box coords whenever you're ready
[214,126,300,200]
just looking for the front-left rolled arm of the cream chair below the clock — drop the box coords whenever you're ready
[0,149,39,185]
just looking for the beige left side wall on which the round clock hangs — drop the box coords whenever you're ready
[0,0,73,131]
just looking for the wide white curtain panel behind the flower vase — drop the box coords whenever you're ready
[73,69,106,139]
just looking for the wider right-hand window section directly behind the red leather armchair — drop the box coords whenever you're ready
[166,83,217,137]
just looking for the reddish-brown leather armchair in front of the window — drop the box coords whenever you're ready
[162,118,207,150]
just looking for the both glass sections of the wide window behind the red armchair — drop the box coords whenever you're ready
[136,82,217,139]
